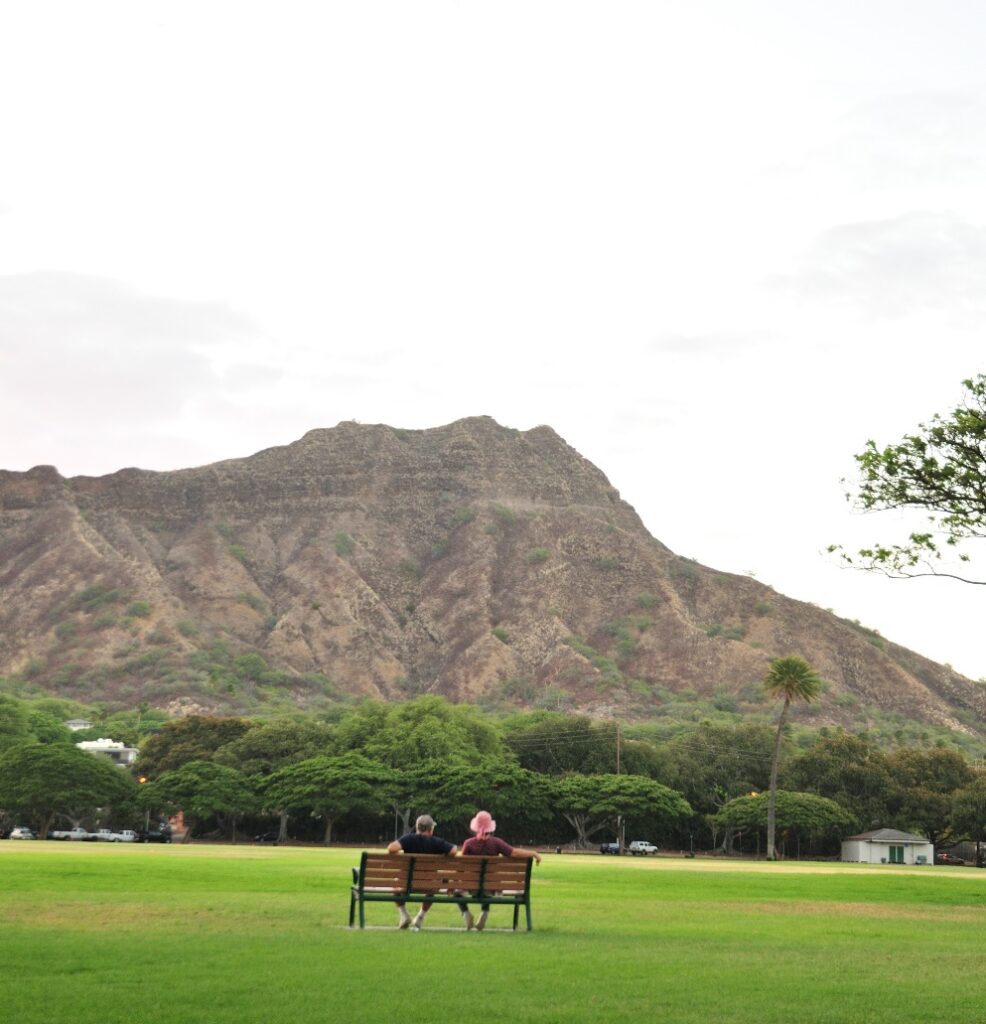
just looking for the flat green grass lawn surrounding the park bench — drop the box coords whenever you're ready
[0,842,986,1024]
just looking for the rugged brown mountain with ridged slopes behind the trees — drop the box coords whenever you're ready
[0,417,986,734]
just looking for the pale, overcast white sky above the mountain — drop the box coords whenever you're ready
[0,6,986,678]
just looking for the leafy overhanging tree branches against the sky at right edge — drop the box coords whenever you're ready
[828,374,986,585]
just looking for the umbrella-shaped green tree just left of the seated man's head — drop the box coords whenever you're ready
[263,752,397,846]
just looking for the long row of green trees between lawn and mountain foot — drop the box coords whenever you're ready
[7,696,986,854]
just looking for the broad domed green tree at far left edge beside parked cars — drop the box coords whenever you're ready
[0,743,136,839]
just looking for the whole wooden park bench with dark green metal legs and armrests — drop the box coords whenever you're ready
[349,853,532,932]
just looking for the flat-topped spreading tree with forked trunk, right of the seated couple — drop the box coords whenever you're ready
[554,773,691,847]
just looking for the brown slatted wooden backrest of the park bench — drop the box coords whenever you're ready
[359,853,531,896]
